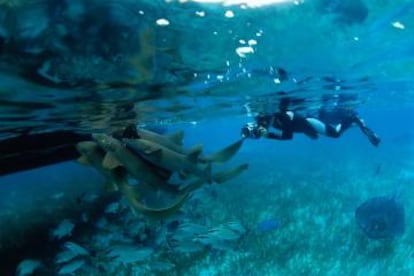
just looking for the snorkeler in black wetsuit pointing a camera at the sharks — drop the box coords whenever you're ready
[241,99,381,146]
